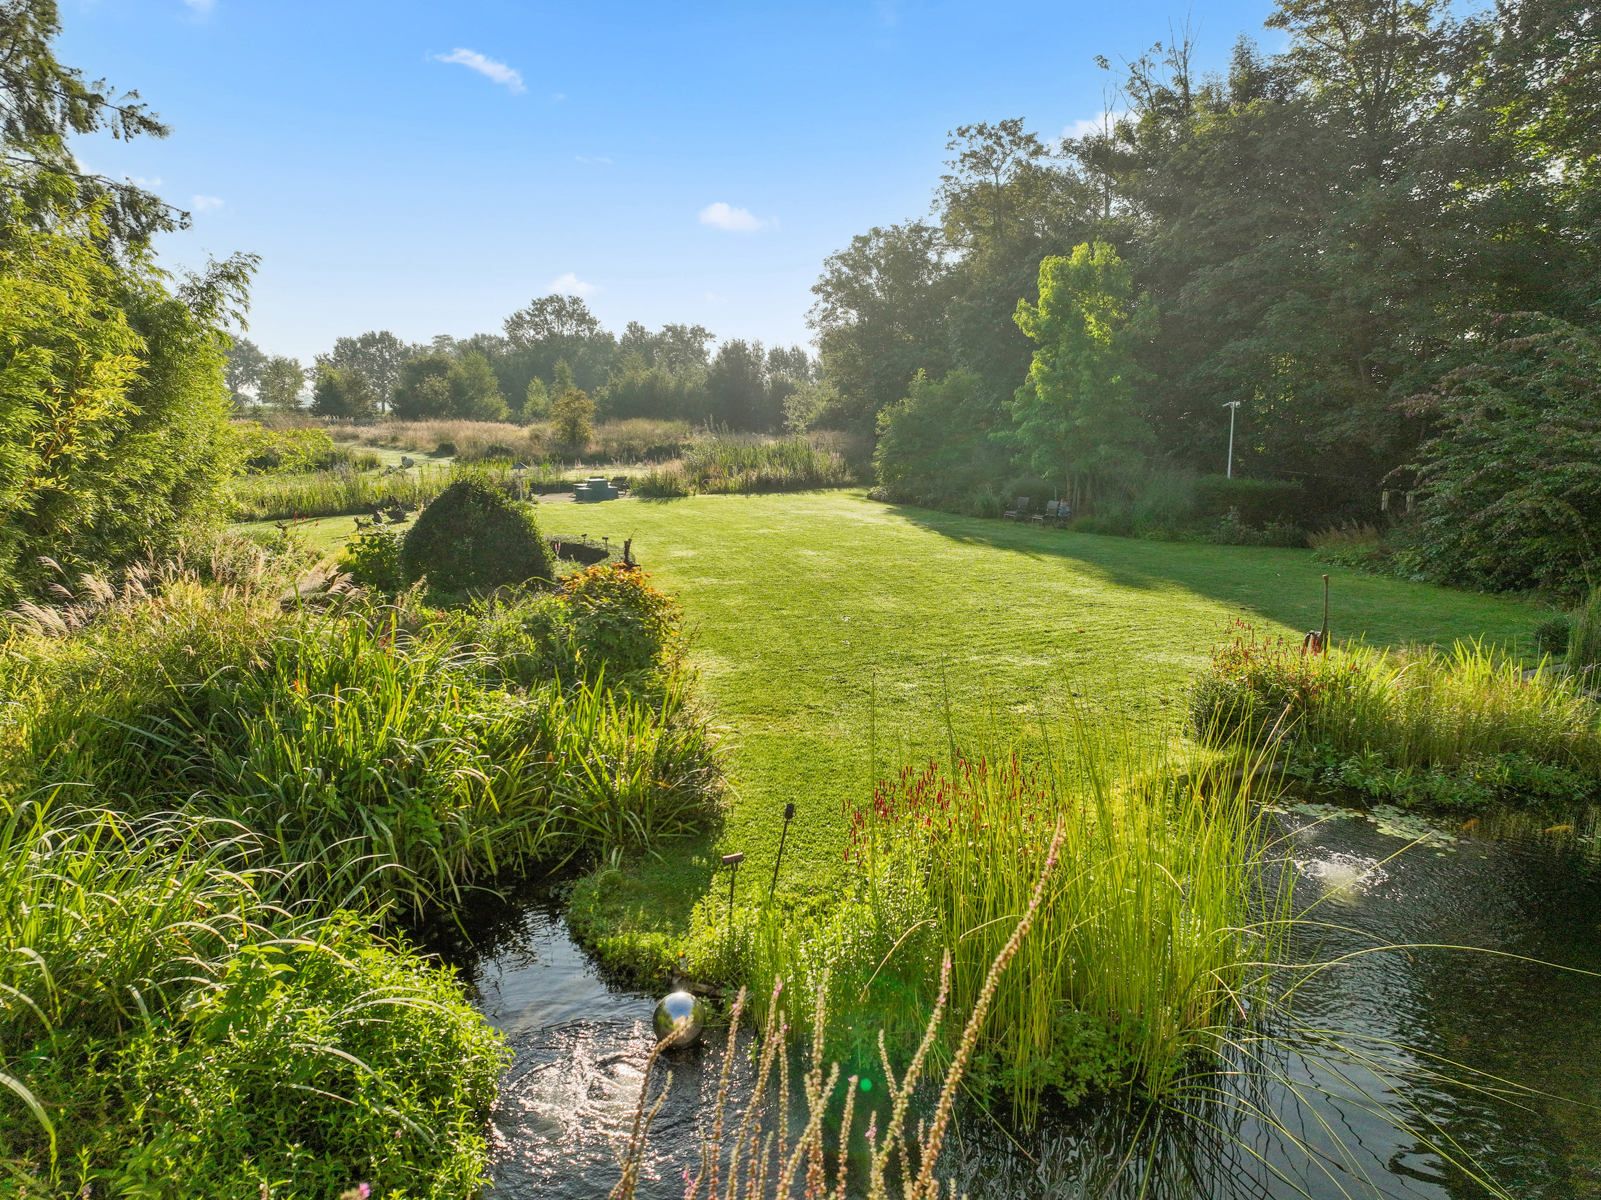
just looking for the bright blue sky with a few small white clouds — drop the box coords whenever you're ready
[59,0,1274,362]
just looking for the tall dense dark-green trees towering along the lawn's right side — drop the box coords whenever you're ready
[812,0,1601,598]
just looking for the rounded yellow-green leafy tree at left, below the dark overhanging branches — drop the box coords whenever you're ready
[0,188,248,603]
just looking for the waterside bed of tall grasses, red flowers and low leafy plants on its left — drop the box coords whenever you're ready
[701,731,1287,1123]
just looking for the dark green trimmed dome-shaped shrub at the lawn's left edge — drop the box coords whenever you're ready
[400,478,556,592]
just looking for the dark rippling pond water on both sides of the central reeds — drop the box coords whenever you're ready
[448,806,1601,1200]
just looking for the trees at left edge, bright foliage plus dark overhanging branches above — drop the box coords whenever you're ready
[0,0,255,605]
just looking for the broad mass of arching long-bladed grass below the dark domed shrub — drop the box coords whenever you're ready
[0,560,717,917]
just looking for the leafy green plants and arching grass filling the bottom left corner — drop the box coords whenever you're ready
[0,802,504,1197]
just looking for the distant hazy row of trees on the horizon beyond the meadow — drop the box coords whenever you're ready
[227,294,815,430]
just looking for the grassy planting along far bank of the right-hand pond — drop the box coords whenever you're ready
[1190,626,1601,808]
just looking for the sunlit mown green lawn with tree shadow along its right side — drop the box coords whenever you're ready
[562,491,1539,926]
